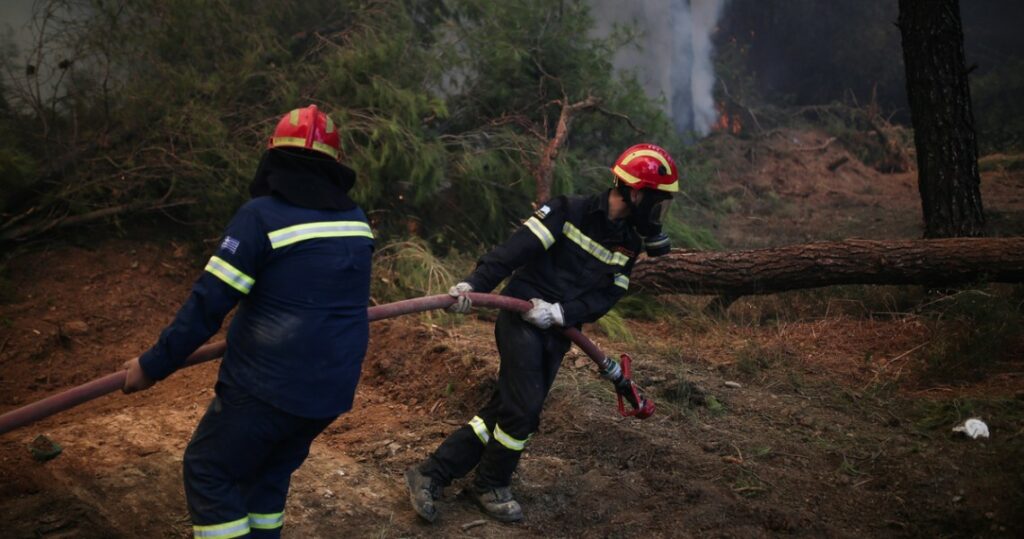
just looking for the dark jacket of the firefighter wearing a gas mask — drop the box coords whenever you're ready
[466,191,643,327]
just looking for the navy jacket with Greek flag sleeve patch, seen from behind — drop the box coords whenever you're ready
[139,196,374,417]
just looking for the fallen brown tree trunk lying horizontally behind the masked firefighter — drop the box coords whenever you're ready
[631,238,1024,298]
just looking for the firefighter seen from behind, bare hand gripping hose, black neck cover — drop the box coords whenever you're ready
[123,106,374,539]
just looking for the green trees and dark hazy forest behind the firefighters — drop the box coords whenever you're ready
[0,0,1024,286]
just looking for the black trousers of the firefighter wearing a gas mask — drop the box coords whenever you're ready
[420,310,571,489]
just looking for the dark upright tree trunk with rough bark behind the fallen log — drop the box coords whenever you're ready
[898,0,985,238]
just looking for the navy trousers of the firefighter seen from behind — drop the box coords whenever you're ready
[183,384,335,539]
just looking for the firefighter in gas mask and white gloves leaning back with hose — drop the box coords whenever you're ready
[406,143,679,523]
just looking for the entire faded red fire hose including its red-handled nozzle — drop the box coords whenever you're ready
[0,292,654,434]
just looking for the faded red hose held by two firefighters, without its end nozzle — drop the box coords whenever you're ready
[0,292,653,434]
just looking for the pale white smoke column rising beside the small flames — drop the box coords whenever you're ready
[590,0,727,135]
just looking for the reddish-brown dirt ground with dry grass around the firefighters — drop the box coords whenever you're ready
[0,133,1024,538]
